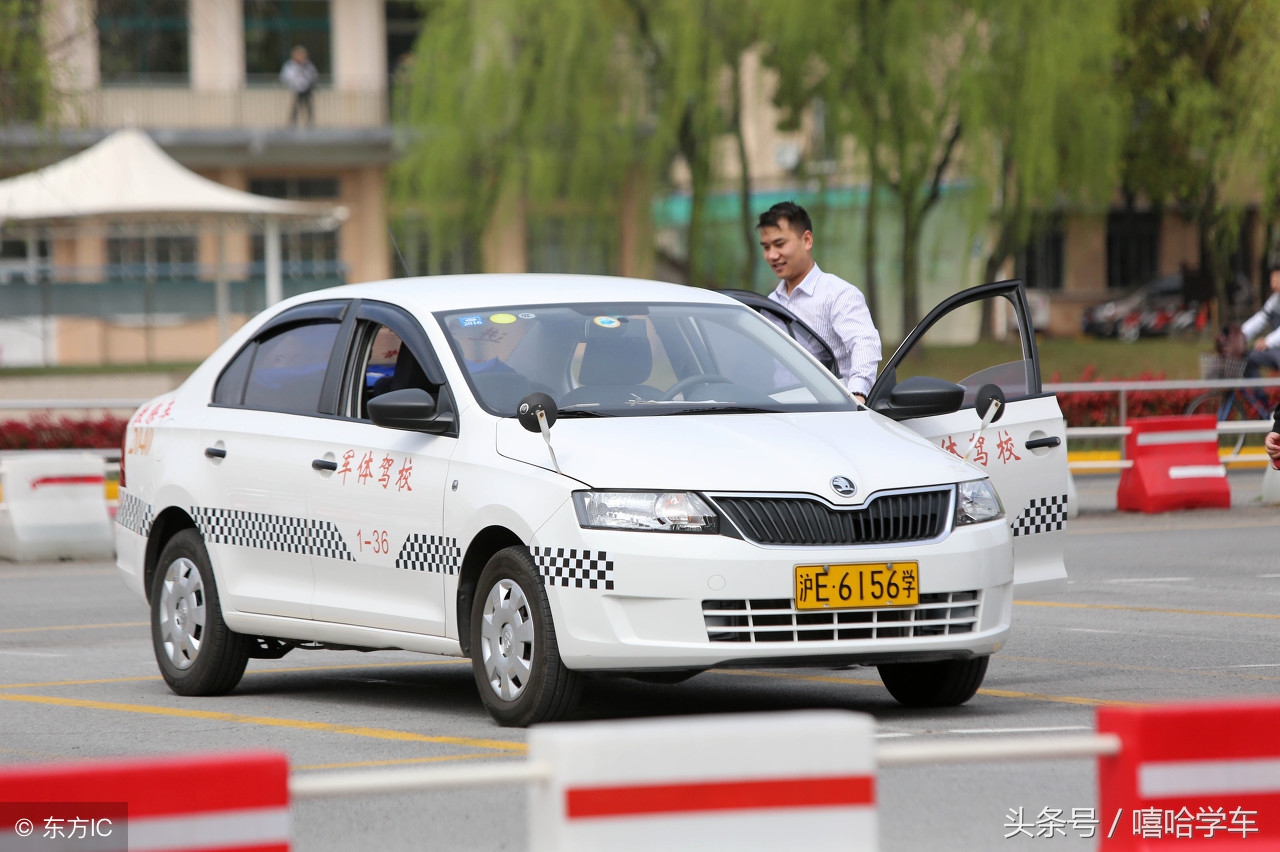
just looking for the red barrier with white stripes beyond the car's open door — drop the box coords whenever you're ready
[1116,414,1231,512]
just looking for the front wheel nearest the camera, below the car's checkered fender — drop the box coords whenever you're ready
[471,548,582,728]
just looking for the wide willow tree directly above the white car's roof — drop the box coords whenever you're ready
[393,0,754,284]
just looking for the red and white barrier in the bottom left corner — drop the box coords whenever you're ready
[0,752,289,852]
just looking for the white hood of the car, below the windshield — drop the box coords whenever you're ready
[495,411,980,505]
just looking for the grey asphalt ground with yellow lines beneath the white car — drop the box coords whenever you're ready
[0,473,1280,852]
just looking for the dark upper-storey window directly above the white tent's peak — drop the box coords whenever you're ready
[96,0,189,84]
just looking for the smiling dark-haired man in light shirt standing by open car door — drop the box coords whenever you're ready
[755,201,881,402]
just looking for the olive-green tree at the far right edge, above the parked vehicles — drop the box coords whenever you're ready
[1120,0,1280,313]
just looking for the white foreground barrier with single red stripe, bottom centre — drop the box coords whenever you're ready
[529,710,877,852]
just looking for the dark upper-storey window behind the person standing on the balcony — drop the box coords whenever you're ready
[244,0,333,86]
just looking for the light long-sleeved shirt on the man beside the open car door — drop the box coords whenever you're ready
[769,264,881,397]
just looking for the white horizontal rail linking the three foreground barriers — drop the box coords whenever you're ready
[289,734,1120,798]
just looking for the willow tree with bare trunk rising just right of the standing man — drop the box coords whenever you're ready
[771,0,980,336]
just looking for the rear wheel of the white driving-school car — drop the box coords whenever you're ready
[151,530,251,696]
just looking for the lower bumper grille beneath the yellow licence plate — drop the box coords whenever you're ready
[703,591,982,642]
